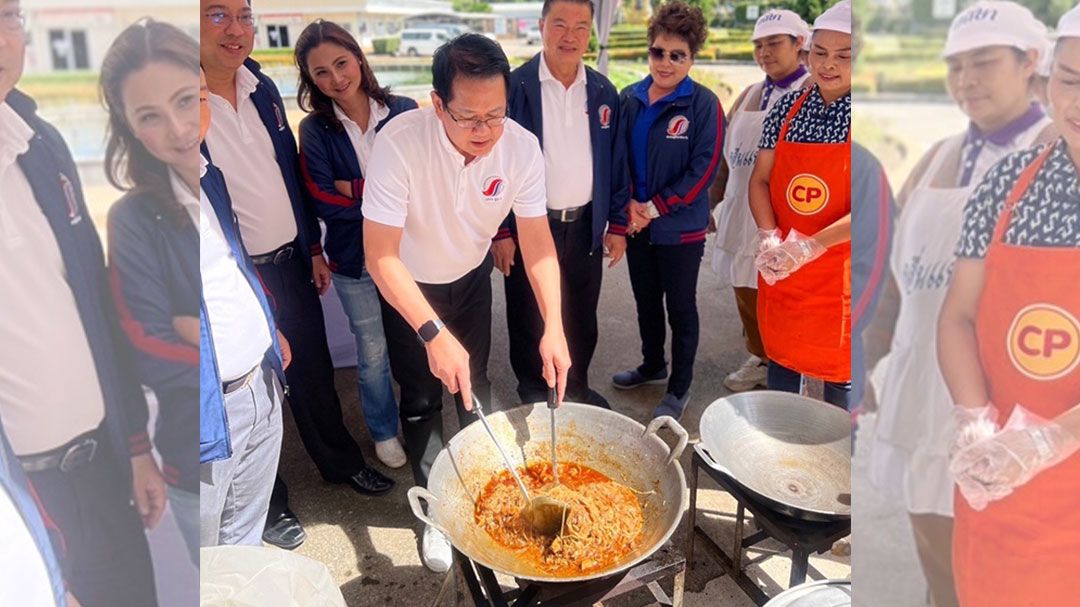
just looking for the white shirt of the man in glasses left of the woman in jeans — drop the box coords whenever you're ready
[206,67,297,255]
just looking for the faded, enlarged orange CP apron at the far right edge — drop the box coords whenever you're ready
[953,146,1080,607]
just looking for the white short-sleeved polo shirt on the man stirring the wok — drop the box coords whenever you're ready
[363,108,546,284]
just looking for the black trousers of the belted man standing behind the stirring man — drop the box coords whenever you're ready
[503,204,607,406]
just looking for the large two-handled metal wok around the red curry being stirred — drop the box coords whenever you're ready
[408,403,688,582]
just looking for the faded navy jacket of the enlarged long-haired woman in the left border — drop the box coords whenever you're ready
[109,191,202,493]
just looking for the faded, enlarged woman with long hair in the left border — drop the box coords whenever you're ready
[100,19,201,565]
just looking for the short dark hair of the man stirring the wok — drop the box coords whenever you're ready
[431,33,510,104]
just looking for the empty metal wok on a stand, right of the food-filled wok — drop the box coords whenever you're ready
[701,391,851,521]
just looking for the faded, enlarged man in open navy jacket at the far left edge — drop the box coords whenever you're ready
[0,7,157,606]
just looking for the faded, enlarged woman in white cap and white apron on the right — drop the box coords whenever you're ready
[869,2,1055,607]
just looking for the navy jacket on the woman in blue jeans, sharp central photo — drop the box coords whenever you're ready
[300,95,417,279]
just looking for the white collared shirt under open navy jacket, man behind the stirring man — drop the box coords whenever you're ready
[540,55,593,211]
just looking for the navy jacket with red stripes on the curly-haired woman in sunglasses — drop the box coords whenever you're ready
[620,76,725,244]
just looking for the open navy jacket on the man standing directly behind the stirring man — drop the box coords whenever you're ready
[494,54,630,251]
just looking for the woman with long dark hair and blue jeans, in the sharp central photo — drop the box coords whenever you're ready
[294,19,417,474]
